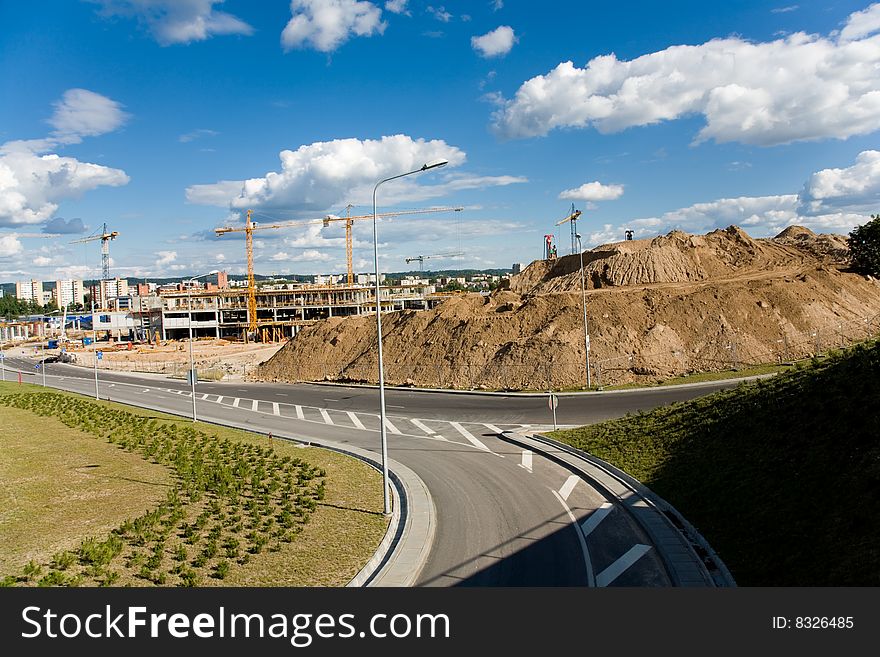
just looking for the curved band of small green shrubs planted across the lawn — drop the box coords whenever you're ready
[0,392,336,586]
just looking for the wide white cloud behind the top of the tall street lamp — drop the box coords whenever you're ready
[187,135,477,211]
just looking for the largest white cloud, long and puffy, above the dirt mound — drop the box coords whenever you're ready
[493,5,880,146]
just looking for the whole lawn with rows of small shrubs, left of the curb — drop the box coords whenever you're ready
[0,384,386,586]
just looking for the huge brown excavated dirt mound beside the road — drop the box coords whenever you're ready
[259,226,880,389]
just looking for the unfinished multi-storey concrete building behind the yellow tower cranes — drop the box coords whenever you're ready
[137,284,443,342]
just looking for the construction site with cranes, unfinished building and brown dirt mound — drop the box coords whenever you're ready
[4,205,880,390]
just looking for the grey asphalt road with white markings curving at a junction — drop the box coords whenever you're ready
[6,354,733,586]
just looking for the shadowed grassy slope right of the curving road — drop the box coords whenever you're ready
[550,342,880,586]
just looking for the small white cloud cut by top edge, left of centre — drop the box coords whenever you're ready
[281,0,387,52]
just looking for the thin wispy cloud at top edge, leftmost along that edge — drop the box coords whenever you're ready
[89,0,254,46]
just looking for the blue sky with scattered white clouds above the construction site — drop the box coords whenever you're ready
[0,0,880,281]
